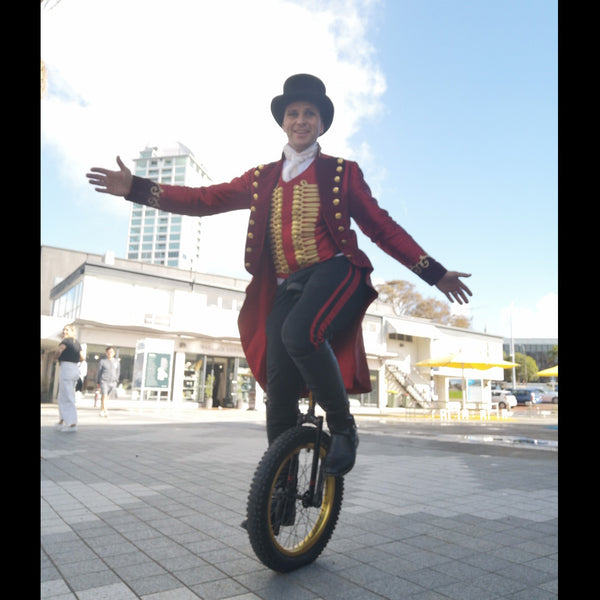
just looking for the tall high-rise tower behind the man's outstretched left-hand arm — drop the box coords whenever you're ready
[127,142,211,269]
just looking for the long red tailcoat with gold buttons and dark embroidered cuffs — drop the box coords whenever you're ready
[127,154,446,393]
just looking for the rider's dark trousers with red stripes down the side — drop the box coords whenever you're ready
[267,256,368,444]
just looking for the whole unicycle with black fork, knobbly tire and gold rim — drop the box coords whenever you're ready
[246,396,344,573]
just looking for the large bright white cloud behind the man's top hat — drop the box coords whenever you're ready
[41,0,385,186]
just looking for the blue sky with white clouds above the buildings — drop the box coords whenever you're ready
[40,0,558,338]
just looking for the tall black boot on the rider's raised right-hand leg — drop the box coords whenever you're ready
[292,342,358,475]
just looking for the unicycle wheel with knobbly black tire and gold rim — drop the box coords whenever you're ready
[246,426,344,573]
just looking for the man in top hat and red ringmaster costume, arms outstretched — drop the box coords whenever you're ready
[87,74,471,475]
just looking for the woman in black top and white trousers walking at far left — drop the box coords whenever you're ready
[54,324,85,433]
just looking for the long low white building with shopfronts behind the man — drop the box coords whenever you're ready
[41,246,504,413]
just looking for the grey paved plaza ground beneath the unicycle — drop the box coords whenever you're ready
[41,400,558,600]
